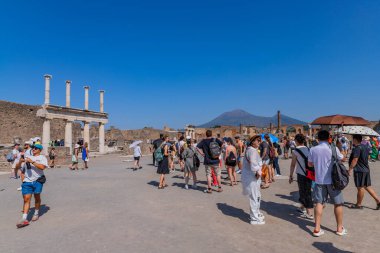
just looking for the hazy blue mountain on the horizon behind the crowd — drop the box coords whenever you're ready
[198,109,307,128]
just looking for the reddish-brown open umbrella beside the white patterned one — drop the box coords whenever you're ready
[311,114,370,126]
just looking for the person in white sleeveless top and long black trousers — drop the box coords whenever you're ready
[289,134,314,220]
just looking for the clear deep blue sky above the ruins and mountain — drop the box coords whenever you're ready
[0,0,380,129]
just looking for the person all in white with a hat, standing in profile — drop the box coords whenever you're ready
[241,135,265,225]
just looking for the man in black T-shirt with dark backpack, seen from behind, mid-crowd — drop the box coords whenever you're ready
[197,130,223,193]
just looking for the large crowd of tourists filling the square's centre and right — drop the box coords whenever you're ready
[153,130,380,237]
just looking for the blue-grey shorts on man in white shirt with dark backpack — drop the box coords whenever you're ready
[313,184,344,205]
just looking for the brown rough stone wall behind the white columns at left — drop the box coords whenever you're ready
[0,100,82,144]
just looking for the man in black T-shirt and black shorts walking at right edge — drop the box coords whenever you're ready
[348,135,380,210]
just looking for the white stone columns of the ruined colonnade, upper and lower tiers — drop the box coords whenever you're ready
[42,75,105,154]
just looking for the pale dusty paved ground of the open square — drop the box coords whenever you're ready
[0,155,380,253]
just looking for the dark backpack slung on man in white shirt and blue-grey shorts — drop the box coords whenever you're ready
[331,145,350,191]
